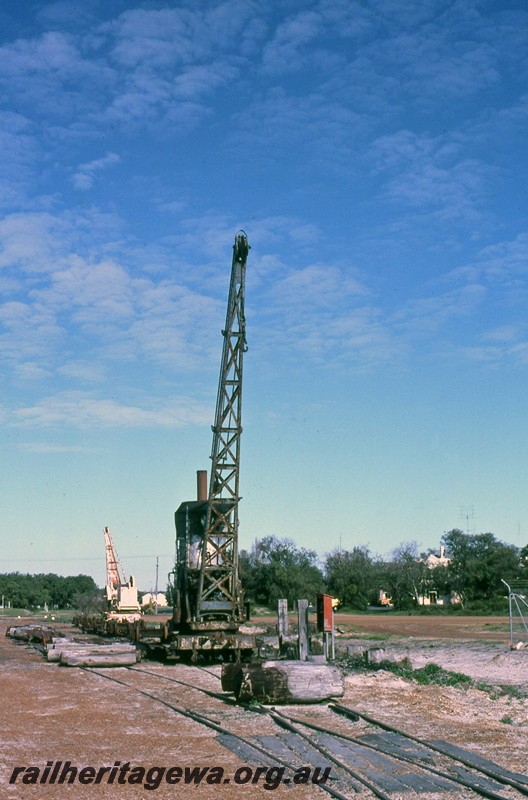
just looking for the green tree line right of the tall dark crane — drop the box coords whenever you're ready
[240,528,528,611]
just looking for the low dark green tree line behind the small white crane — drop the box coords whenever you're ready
[0,572,99,610]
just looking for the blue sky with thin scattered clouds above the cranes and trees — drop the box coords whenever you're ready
[0,0,528,589]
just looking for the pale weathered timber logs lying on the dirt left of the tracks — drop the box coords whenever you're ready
[46,639,140,667]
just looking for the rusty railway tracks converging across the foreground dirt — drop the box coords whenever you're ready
[81,666,528,800]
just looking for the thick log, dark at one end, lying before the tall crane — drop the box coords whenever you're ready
[222,661,344,704]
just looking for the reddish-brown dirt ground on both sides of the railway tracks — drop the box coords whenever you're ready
[0,614,528,800]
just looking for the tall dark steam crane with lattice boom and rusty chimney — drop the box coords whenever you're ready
[170,231,254,659]
